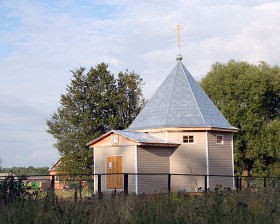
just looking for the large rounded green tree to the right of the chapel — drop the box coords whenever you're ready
[201,60,280,175]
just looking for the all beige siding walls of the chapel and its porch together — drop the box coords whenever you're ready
[94,131,233,194]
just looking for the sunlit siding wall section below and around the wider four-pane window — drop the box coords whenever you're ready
[168,131,207,191]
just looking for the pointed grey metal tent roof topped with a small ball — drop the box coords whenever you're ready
[127,55,237,131]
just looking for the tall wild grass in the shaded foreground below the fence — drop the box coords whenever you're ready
[0,189,280,224]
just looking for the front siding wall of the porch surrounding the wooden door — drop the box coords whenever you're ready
[94,146,135,192]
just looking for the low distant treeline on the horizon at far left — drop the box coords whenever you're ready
[0,166,49,176]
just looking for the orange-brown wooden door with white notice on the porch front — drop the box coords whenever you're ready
[106,156,123,189]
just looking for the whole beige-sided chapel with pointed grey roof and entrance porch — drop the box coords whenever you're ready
[87,54,238,194]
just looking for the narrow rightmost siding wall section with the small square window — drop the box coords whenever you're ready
[208,132,234,189]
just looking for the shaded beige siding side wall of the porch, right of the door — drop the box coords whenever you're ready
[137,147,171,194]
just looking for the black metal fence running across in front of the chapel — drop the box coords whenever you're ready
[0,173,280,198]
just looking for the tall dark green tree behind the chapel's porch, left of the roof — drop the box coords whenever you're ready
[47,63,144,174]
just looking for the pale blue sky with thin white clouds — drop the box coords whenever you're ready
[0,0,280,167]
